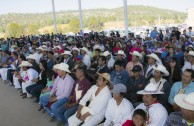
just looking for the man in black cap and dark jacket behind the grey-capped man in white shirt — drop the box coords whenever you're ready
[127,65,147,106]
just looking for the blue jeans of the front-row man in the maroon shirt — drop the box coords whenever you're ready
[57,105,78,123]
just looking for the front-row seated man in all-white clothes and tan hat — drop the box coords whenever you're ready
[68,73,111,126]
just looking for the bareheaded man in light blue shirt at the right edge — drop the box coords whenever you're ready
[168,69,194,110]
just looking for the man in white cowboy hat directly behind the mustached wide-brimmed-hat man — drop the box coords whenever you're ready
[148,64,172,112]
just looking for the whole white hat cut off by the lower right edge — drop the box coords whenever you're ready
[174,92,194,111]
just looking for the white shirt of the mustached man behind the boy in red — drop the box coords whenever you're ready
[129,103,168,126]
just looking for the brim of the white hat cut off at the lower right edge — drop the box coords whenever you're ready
[174,94,194,111]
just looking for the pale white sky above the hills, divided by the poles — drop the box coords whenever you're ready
[0,0,194,15]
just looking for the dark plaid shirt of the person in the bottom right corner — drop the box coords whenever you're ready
[165,112,194,126]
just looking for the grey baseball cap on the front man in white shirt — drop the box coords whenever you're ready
[111,83,127,93]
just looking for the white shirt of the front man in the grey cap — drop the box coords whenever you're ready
[104,98,134,126]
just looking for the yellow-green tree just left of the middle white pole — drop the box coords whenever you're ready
[69,18,80,33]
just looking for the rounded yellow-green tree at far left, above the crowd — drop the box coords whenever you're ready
[6,23,23,37]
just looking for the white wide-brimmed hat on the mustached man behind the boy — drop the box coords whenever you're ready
[137,83,164,95]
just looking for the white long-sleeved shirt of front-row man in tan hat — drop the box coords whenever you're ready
[79,85,111,116]
